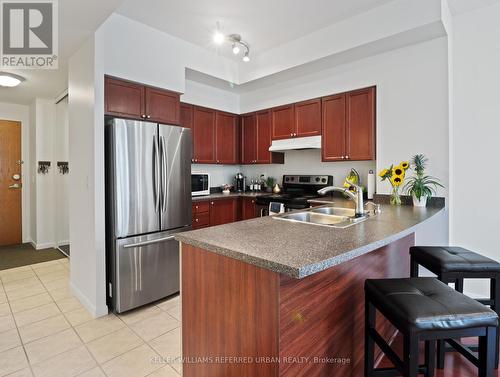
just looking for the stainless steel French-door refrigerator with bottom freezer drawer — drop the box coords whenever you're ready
[105,118,192,313]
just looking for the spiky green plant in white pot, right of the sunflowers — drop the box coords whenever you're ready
[404,154,444,207]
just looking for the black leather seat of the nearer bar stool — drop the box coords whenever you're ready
[365,277,498,331]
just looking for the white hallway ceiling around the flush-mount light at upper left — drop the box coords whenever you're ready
[0,0,121,104]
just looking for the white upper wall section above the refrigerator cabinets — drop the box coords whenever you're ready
[99,14,238,93]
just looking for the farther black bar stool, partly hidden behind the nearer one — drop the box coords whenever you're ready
[410,246,500,369]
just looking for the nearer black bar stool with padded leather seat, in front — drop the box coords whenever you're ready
[365,278,498,377]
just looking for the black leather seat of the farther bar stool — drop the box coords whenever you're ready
[410,246,500,272]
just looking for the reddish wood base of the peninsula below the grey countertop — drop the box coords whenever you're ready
[181,234,415,377]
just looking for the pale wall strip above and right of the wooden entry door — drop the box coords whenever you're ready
[0,103,30,242]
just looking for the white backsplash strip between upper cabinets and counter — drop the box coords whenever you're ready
[192,149,375,191]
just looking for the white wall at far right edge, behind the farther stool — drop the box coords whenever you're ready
[450,4,500,295]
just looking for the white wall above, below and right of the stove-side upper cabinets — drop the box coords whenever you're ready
[240,38,449,244]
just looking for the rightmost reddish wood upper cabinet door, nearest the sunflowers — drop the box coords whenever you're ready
[346,87,375,161]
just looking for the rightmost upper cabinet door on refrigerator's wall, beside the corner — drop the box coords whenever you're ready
[215,111,239,164]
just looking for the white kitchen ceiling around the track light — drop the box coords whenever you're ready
[117,0,394,56]
